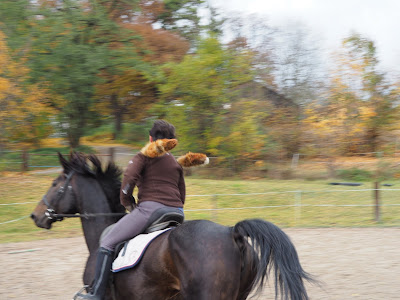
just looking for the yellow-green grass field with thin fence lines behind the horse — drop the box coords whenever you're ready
[0,173,400,243]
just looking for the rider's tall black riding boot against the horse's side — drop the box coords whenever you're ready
[74,247,114,300]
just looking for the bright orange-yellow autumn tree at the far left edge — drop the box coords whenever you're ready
[0,31,54,148]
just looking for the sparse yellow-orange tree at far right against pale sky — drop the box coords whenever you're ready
[304,35,398,155]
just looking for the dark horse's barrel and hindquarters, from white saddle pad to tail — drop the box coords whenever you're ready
[115,221,241,300]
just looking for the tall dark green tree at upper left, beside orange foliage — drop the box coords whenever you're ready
[25,0,146,148]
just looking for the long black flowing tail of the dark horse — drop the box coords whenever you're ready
[233,219,315,300]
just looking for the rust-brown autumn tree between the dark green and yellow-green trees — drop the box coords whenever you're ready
[90,0,203,138]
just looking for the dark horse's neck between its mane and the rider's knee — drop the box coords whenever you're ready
[77,179,115,253]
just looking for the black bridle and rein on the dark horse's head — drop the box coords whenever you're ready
[42,171,126,222]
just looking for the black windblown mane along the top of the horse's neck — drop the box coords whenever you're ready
[59,152,125,211]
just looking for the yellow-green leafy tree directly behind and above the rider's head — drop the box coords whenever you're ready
[160,37,252,153]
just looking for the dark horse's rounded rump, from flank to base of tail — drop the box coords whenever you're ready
[169,221,241,300]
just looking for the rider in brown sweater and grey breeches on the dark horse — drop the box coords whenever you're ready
[74,120,186,299]
